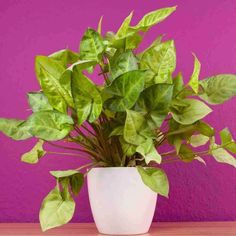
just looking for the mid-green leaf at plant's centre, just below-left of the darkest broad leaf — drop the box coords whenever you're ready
[124,110,145,145]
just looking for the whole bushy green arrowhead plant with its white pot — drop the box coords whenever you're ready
[0,7,236,235]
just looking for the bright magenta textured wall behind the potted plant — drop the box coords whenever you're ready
[0,0,236,222]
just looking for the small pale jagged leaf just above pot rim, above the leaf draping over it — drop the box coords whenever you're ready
[136,138,161,164]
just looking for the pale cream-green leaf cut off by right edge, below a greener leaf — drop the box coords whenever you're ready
[211,144,236,167]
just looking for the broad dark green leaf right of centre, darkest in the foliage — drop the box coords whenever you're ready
[135,84,173,128]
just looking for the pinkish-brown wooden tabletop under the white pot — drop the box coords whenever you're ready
[0,221,236,236]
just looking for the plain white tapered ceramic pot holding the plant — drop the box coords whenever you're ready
[88,167,157,235]
